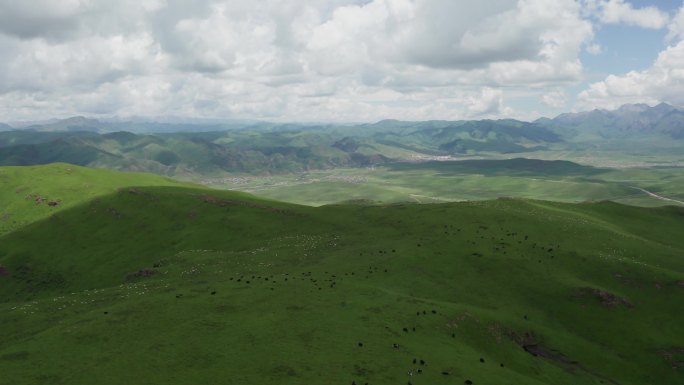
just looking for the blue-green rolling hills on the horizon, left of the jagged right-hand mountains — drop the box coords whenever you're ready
[0,117,562,176]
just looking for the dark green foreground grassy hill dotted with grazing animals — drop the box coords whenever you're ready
[0,165,684,385]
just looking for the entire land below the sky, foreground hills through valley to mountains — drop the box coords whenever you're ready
[0,103,684,385]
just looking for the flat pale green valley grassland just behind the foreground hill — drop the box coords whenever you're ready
[203,159,684,207]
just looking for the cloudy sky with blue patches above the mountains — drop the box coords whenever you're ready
[0,0,684,123]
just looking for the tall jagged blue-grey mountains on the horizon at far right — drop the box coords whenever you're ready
[536,103,684,139]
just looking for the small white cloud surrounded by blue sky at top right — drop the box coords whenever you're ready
[585,0,670,29]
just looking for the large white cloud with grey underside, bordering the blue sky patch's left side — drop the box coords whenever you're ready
[309,0,593,82]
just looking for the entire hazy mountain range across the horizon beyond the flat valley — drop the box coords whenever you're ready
[0,104,684,176]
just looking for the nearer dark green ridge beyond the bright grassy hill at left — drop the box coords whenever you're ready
[0,130,390,176]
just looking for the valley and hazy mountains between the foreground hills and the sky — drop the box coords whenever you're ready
[0,105,684,206]
